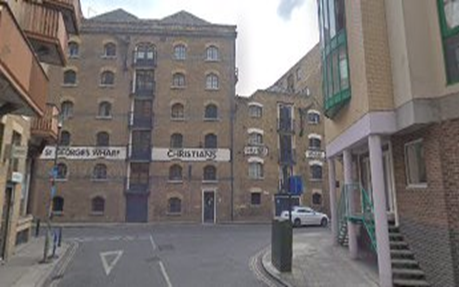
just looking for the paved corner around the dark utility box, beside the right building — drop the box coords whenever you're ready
[262,228,379,287]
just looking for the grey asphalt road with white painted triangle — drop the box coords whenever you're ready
[54,225,276,287]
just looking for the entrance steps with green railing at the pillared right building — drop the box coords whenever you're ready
[337,184,430,287]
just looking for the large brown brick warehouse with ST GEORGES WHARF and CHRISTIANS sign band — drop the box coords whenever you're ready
[29,10,237,222]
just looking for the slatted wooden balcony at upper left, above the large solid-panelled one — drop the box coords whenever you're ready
[22,2,68,66]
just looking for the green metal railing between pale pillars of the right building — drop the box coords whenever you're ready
[336,183,376,251]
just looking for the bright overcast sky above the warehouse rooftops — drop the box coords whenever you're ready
[80,0,319,96]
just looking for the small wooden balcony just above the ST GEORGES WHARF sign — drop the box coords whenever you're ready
[30,104,59,143]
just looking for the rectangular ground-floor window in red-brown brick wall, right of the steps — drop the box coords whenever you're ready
[405,140,427,185]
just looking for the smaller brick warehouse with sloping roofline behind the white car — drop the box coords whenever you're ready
[234,45,329,220]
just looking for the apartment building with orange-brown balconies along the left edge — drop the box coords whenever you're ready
[0,0,81,260]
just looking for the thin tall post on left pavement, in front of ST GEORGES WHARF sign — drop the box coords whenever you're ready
[43,114,62,263]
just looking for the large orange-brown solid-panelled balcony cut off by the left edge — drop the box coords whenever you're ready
[0,1,48,116]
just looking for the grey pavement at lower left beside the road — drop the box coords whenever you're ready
[0,237,75,287]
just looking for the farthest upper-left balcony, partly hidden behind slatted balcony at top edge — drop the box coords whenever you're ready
[43,0,82,34]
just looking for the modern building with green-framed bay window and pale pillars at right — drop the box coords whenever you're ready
[318,0,459,286]
